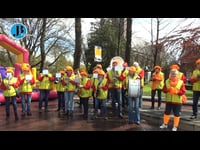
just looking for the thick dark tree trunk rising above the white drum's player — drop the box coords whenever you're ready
[125,18,132,64]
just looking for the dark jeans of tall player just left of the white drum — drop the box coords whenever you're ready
[110,89,122,115]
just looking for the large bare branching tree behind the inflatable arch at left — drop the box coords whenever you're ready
[0,18,74,71]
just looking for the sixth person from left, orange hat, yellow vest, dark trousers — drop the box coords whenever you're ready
[78,70,91,119]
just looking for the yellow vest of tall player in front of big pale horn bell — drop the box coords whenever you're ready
[107,69,122,89]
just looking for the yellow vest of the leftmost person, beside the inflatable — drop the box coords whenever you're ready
[3,77,17,97]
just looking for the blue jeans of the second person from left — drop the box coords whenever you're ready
[21,94,32,113]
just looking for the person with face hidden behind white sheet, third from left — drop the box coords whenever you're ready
[38,69,54,113]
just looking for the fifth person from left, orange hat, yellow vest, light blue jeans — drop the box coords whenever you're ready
[62,66,76,117]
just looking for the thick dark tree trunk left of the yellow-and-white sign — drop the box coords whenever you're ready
[74,18,82,69]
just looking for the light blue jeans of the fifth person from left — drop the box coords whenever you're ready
[64,92,74,112]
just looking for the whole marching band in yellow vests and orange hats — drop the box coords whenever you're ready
[0,60,200,131]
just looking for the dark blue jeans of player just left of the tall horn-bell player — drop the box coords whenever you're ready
[94,98,107,117]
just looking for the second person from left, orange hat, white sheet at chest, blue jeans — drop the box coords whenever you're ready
[18,63,35,116]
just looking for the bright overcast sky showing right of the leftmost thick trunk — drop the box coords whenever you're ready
[82,18,200,43]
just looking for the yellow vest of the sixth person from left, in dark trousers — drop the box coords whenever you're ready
[78,78,91,98]
